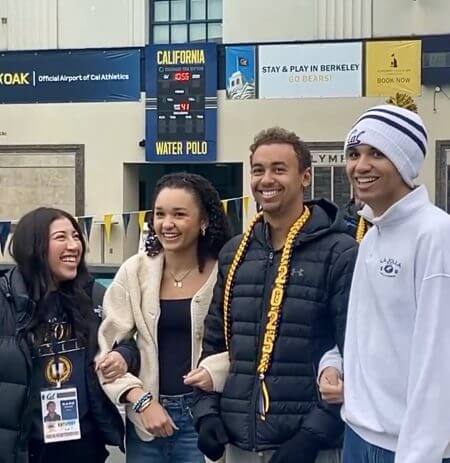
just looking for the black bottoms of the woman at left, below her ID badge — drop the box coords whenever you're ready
[28,434,108,463]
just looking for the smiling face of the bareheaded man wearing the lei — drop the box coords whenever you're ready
[251,143,311,217]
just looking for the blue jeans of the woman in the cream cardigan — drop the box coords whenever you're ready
[126,394,205,463]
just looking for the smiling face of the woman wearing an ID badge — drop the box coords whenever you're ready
[47,217,83,283]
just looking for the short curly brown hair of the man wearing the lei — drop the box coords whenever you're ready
[250,127,311,171]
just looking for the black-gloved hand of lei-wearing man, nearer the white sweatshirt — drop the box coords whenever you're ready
[269,431,319,463]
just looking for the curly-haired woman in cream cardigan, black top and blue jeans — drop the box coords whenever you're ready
[99,173,230,463]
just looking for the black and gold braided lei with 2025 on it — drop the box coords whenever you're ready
[223,206,311,420]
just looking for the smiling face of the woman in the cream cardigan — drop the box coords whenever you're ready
[153,188,207,252]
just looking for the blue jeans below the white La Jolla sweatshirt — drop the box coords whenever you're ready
[343,426,450,463]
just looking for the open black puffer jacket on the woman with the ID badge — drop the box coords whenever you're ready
[0,269,139,463]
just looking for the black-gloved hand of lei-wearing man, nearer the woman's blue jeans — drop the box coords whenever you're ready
[197,415,228,461]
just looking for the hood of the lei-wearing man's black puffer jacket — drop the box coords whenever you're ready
[254,198,348,248]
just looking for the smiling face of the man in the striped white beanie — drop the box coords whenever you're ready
[346,145,411,216]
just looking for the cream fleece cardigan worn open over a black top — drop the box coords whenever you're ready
[98,253,229,441]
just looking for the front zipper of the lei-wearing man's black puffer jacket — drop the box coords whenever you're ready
[250,248,275,452]
